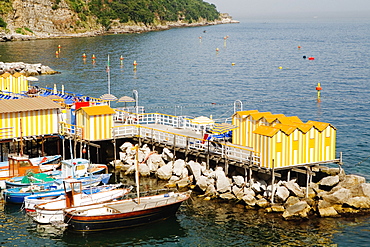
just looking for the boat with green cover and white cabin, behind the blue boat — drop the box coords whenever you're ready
[5,158,108,188]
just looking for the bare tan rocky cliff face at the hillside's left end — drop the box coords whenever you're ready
[3,0,101,36]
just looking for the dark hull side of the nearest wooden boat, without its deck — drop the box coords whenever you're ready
[64,201,182,232]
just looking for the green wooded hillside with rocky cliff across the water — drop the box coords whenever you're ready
[0,0,220,33]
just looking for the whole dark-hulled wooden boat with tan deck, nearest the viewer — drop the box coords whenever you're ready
[64,189,190,232]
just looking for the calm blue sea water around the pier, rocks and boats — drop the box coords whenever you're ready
[0,19,370,246]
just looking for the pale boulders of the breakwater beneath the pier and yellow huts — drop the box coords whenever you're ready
[111,142,370,220]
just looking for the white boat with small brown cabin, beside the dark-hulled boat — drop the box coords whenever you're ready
[32,180,132,224]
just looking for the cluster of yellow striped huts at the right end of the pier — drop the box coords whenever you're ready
[232,110,336,168]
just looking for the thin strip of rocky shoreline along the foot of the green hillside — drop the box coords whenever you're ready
[0,19,240,42]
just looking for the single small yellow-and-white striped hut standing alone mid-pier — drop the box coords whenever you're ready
[76,105,115,141]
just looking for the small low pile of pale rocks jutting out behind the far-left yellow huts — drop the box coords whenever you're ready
[0,62,59,76]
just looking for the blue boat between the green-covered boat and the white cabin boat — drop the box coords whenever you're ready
[3,174,112,204]
